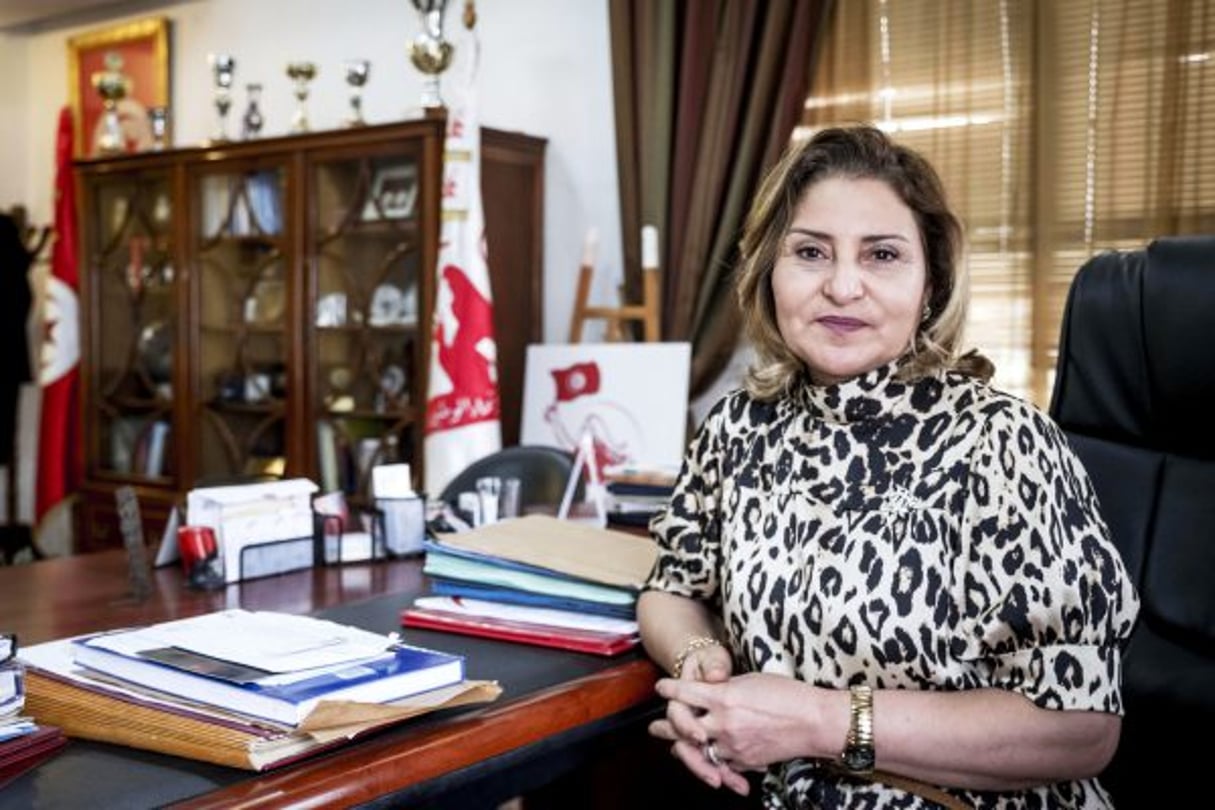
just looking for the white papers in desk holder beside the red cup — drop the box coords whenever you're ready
[186,478,317,584]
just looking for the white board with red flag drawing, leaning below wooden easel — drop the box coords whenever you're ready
[520,342,691,480]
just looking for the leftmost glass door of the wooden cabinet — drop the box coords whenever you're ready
[85,170,177,482]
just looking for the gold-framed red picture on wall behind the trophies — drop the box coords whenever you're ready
[68,17,169,157]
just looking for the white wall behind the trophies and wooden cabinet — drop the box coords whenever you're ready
[0,0,621,341]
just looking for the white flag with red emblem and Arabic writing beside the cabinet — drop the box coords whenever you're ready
[424,37,502,497]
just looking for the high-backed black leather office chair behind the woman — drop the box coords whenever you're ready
[1050,237,1215,809]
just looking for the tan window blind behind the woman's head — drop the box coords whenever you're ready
[795,0,1215,406]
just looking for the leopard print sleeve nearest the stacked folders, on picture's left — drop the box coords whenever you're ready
[645,393,739,600]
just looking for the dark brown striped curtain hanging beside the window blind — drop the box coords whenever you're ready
[609,0,832,396]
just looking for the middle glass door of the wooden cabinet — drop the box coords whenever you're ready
[191,166,290,482]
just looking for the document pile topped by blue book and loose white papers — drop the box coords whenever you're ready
[21,610,501,770]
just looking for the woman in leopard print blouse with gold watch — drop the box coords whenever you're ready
[638,128,1138,808]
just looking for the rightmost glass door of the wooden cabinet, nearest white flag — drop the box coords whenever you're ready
[309,145,424,499]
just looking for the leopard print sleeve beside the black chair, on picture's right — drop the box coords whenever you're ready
[955,397,1138,713]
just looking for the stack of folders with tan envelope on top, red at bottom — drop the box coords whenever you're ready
[401,515,656,655]
